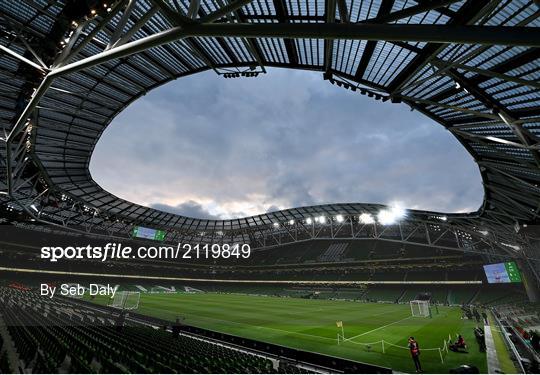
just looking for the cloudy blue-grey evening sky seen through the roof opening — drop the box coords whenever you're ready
[90,69,483,218]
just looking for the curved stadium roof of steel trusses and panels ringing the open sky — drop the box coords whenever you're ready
[0,0,540,264]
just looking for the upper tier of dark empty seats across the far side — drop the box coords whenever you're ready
[0,227,494,282]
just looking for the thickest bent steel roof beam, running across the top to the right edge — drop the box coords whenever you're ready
[8,23,540,84]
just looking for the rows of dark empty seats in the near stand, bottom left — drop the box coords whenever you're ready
[0,287,386,374]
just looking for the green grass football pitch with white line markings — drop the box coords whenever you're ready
[87,293,487,373]
